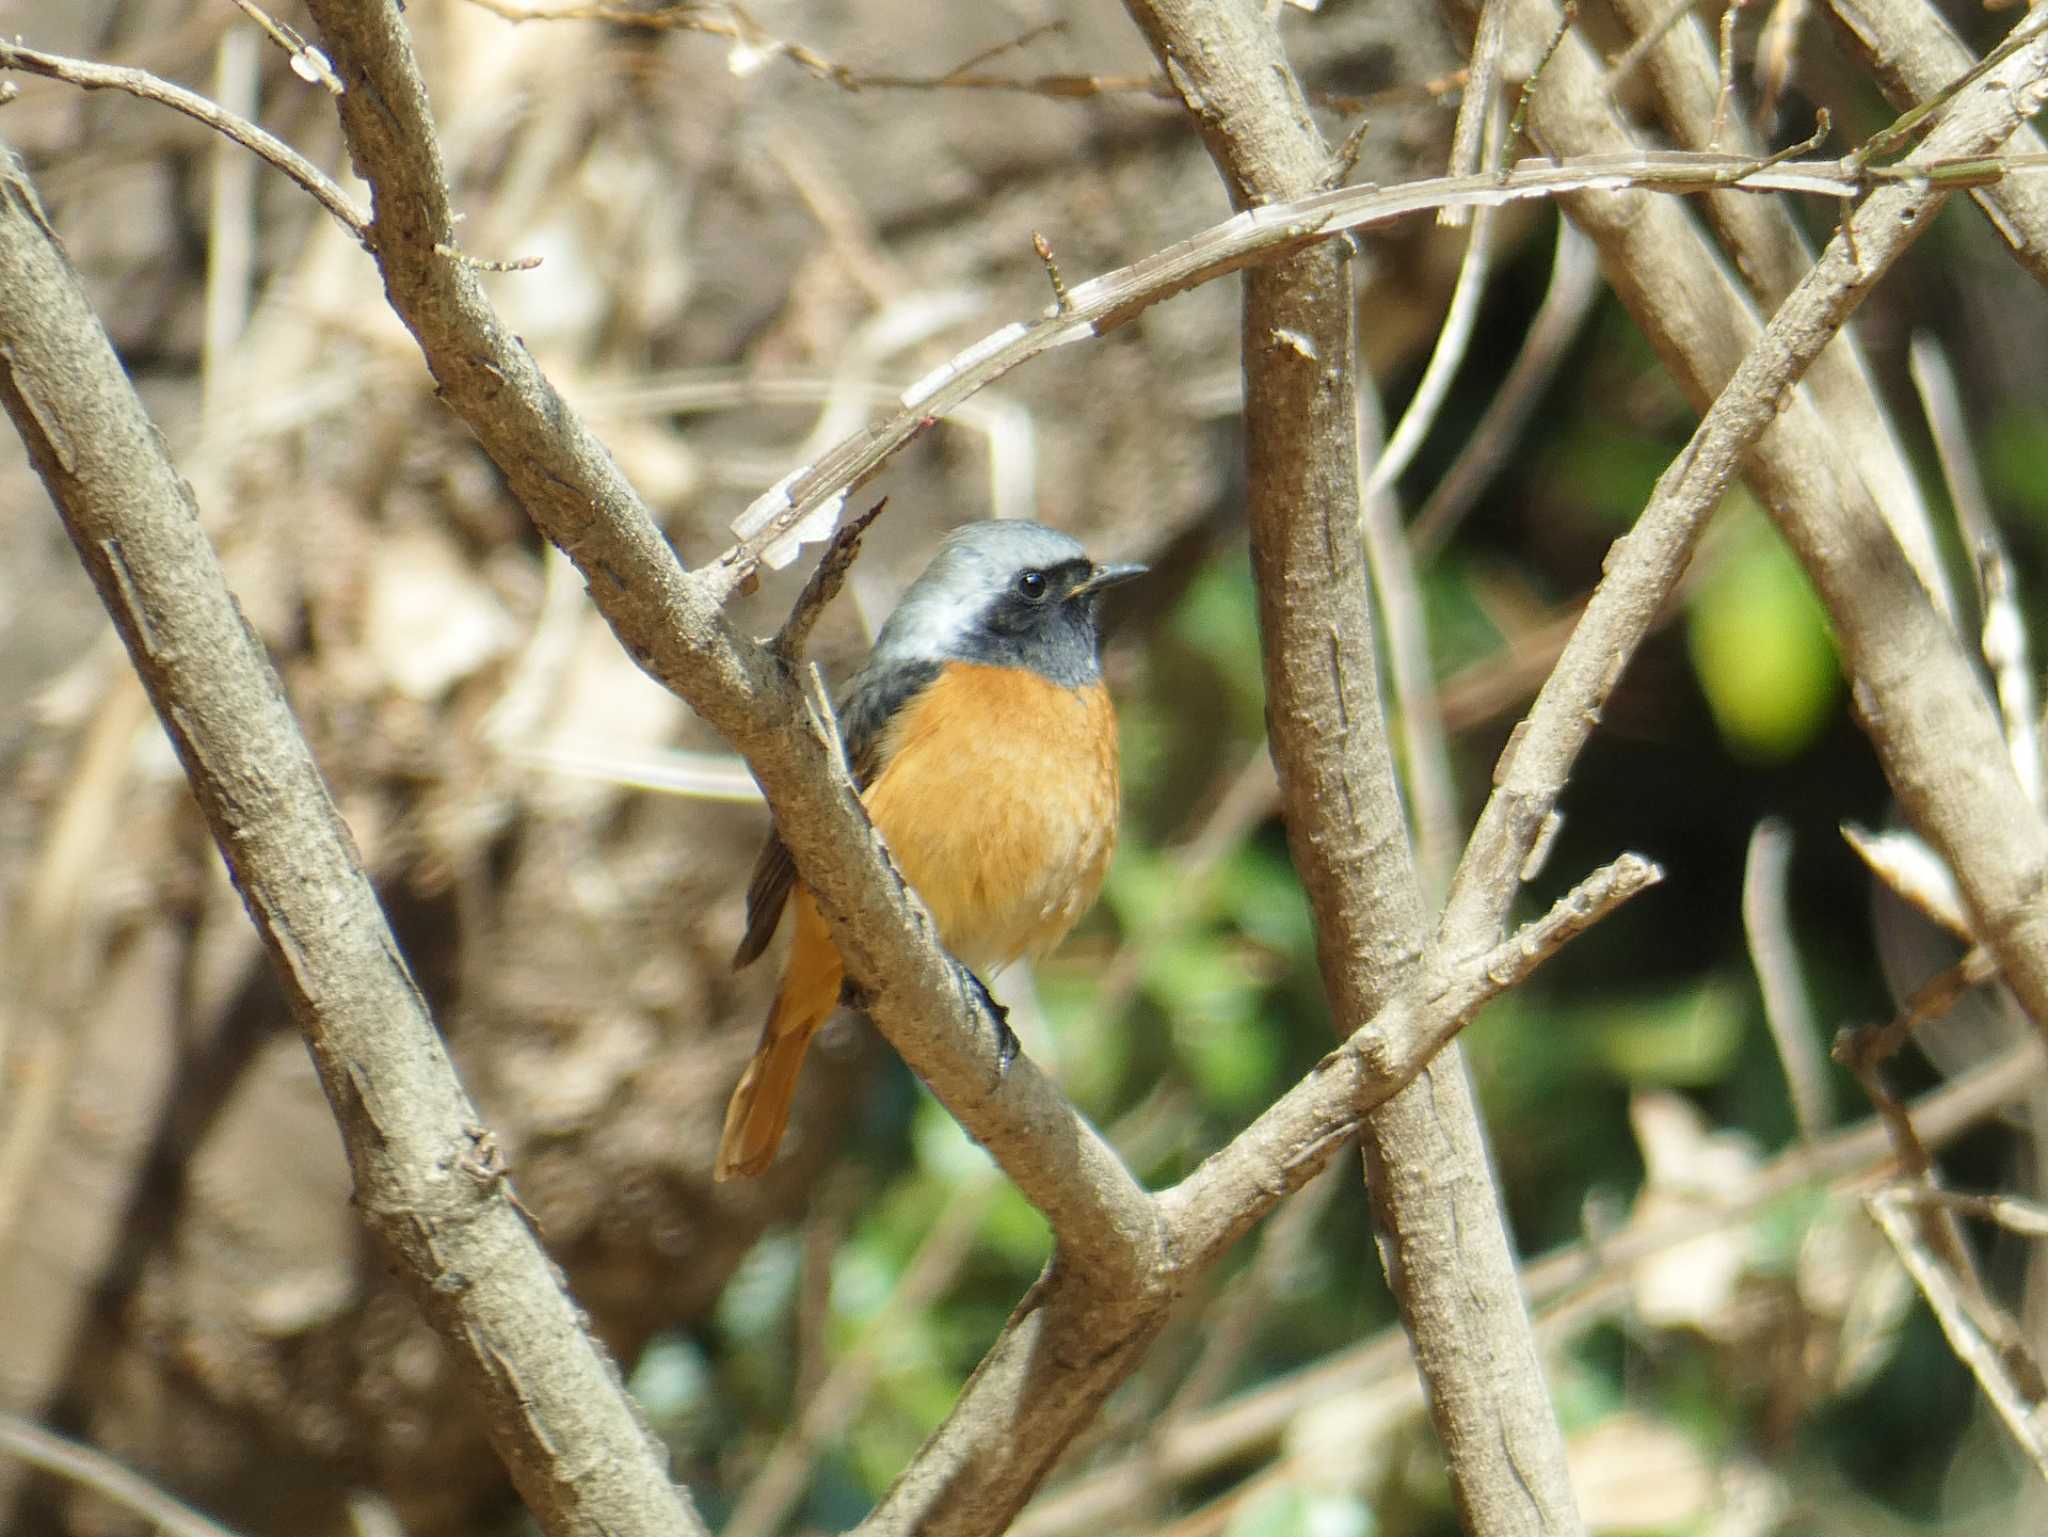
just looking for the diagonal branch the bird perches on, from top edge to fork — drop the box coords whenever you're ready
[288,0,1159,1295]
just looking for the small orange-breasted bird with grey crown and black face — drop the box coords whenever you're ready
[717,518,1145,1180]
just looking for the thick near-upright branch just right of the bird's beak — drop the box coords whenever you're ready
[1126,0,1579,1533]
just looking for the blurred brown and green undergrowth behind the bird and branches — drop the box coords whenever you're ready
[0,0,2048,1537]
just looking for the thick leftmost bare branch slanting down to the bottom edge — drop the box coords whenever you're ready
[0,141,702,1537]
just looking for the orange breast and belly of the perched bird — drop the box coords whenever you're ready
[866,662,1118,975]
